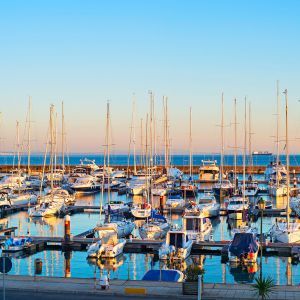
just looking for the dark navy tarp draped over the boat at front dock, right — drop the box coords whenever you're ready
[229,232,258,257]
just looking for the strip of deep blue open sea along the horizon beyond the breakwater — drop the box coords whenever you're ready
[0,154,300,166]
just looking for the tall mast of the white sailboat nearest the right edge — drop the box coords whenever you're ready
[284,89,290,225]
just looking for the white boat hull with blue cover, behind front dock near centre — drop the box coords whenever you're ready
[139,211,170,240]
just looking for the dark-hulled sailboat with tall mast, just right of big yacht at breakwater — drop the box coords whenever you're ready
[213,93,234,199]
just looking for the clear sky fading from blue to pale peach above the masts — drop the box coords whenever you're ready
[0,0,300,153]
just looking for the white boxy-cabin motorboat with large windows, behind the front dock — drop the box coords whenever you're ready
[182,208,212,241]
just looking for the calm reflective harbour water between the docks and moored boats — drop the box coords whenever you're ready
[0,189,300,284]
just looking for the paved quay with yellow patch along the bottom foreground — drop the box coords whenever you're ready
[0,275,300,300]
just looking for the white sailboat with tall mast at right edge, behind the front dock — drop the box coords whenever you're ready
[270,90,300,243]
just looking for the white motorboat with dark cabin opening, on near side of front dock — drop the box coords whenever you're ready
[158,230,193,261]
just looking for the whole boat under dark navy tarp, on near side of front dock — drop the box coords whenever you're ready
[228,232,259,264]
